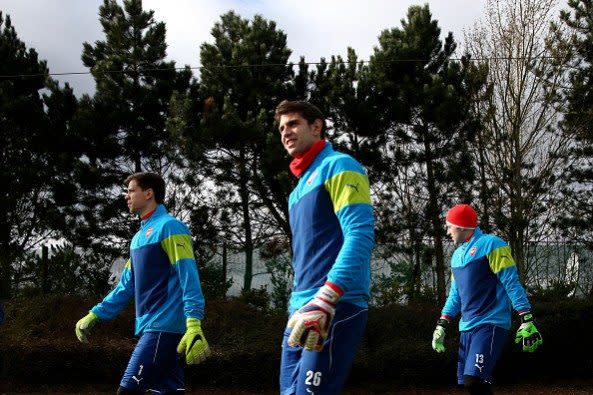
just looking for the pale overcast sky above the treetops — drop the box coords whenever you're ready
[0,0,486,95]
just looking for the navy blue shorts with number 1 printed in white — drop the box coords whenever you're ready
[119,332,185,394]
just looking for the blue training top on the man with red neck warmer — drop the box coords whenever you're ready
[288,143,374,312]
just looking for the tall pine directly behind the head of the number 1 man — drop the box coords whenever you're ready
[70,0,191,253]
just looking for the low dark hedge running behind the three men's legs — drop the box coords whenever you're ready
[0,295,593,390]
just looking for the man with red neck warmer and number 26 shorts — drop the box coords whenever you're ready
[276,100,374,395]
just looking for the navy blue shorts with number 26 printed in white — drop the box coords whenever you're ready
[280,302,368,395]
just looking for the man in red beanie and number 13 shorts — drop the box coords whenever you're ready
[432,204,542,395]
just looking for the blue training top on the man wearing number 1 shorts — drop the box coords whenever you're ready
[91,204,204,335]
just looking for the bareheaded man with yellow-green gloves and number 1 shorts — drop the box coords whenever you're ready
[75,173,210,395]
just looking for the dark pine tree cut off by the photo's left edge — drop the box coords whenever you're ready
[0,13,78,298]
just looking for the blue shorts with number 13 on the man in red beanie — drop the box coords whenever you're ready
[457,325,509,384]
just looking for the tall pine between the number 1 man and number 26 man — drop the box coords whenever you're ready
[193,11,292,291]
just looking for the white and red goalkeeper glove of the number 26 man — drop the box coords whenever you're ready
[286,281,344,351]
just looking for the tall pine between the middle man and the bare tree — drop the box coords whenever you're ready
[369,5,476,301]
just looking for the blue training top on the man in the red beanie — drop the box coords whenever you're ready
[442,228,531,331]
